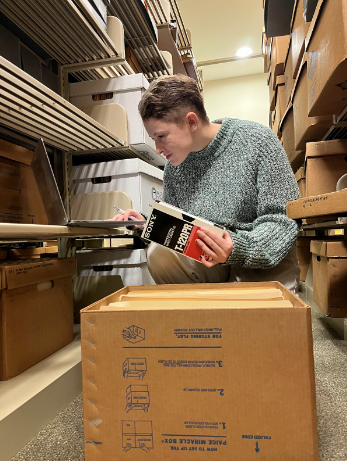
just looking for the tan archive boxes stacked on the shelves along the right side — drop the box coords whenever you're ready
[263,0,347,317]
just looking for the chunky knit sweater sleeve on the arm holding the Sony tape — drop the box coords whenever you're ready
[225,128,300,269]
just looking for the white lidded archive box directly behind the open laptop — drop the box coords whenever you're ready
[73,158,163,213]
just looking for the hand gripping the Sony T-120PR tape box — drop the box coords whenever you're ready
[196,228,234,267]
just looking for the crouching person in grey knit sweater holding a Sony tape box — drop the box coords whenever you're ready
[113,75,300,292]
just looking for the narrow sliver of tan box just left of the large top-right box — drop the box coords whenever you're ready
[290,0,310,79]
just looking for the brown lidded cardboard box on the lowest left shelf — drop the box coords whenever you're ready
[0,258,76,380]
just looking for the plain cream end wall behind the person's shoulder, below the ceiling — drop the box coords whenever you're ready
[203,74,270,126]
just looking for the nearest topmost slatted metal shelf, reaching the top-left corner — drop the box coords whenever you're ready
[0,0,133,80]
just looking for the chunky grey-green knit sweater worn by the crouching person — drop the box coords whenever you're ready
[163,118,300,269]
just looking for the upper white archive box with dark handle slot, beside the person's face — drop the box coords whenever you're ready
[70,74,166,165]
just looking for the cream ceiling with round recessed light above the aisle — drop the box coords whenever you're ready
[177,0,264,81]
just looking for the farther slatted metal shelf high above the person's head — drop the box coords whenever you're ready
[108,0,169,80]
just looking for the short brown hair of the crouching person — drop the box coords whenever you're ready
[138,74,208,124]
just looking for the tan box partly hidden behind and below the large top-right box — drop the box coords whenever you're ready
[293,60,333,150]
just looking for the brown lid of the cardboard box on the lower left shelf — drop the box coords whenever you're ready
[0,258,76,290]
